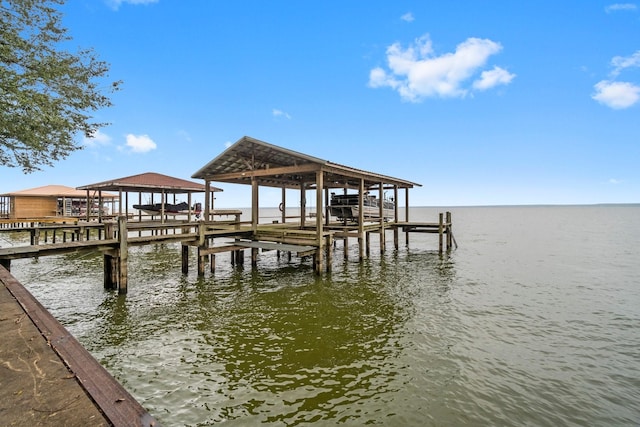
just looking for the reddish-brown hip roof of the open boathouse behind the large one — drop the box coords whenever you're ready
[78,172,222,194]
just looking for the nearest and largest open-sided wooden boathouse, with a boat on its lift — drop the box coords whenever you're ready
[191,136,420,272]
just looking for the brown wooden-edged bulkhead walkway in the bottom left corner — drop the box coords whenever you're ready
[0,266,159,427]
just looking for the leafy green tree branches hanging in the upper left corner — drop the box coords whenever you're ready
[0,0,119,173]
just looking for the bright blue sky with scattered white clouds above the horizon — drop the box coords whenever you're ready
[0,0,640,207]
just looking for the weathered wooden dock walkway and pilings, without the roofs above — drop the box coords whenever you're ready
[0,211,457,293]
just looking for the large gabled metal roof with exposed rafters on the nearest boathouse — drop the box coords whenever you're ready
[191,136,420,188]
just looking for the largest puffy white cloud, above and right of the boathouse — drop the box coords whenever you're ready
[369,35,515,102]
